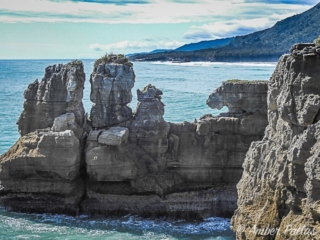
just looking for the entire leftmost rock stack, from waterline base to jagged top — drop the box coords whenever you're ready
[0,61,85,215]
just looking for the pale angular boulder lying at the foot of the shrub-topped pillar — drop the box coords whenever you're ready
[98,127,129,146]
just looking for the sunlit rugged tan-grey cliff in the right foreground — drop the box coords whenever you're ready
[232,44,320,239]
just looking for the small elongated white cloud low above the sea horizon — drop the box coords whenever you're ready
[89,40,184,52]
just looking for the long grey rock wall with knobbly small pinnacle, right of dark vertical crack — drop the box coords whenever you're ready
[81,82,267,218]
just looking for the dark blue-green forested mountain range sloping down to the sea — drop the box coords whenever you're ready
[129,3,320,61]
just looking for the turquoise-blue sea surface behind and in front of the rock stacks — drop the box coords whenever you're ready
[0,60,276,240]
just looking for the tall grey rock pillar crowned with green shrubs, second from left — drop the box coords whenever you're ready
[90,55,135,128]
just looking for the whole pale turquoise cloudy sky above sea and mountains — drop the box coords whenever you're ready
[0,0,319,59]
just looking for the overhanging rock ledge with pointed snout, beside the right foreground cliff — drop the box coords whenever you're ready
[207,80,268,113]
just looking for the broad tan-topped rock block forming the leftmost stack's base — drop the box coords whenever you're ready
[0,130,84,214]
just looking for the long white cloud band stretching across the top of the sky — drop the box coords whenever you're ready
[0,0,316,23]
